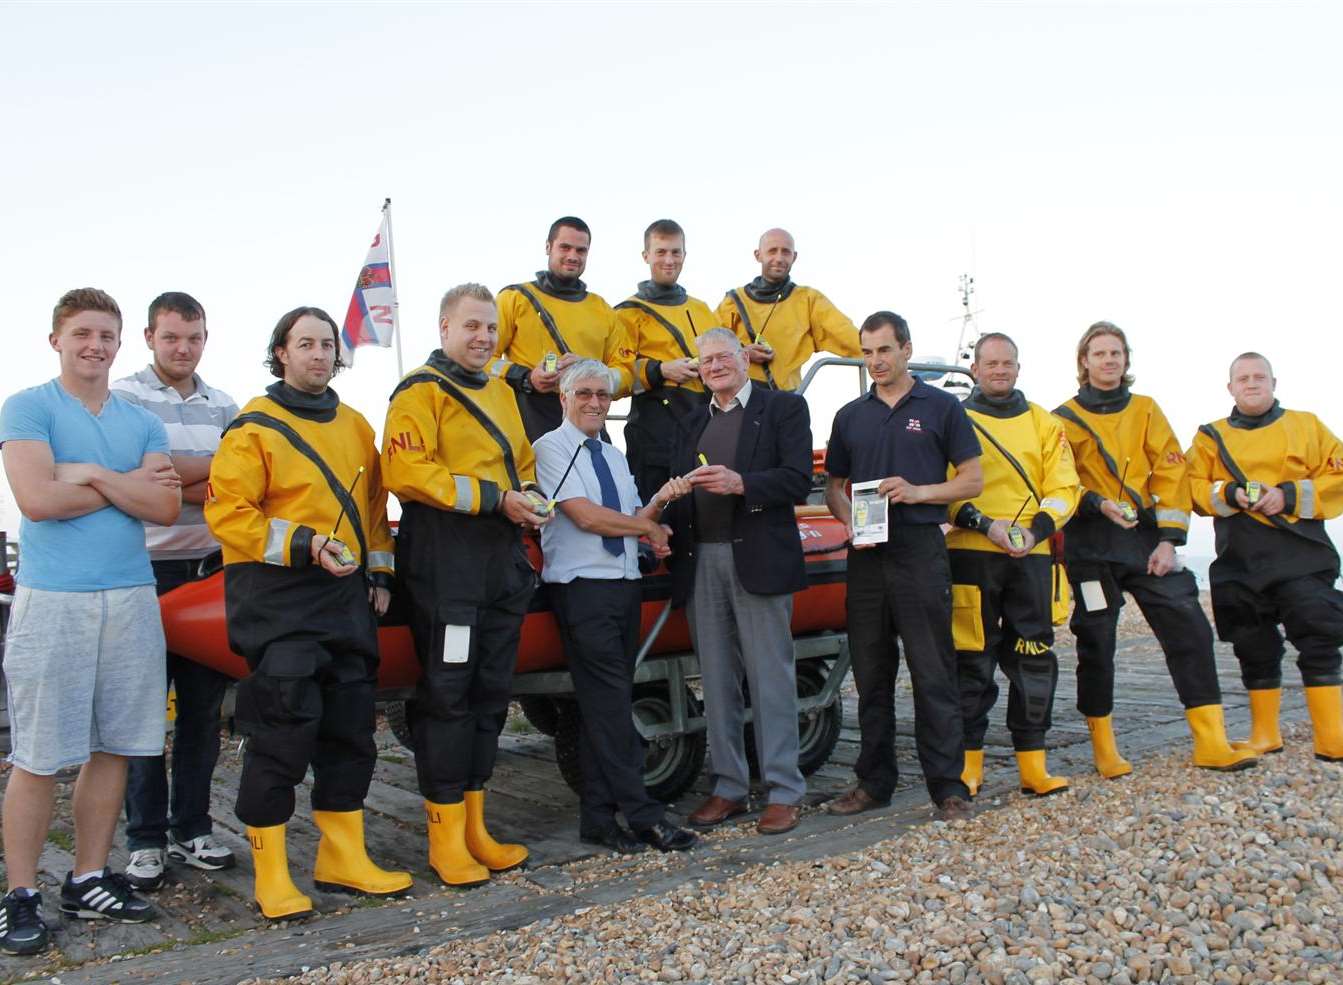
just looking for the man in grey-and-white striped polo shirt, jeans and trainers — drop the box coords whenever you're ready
[111,292,238,890]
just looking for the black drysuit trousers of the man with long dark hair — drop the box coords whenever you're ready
[224,563,377,828]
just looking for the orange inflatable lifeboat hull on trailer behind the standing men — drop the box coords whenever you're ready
[158,505,847,691]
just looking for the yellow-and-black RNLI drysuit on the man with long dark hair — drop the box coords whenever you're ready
[204,383,393,828]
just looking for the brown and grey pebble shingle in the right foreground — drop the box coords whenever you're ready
[247,727,1343,985]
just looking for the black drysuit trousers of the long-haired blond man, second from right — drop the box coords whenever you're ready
[1068,560,1222,718]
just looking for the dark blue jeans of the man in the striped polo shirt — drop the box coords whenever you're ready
[126,560,230,852]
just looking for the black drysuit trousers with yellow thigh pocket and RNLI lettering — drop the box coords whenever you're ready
[950,551,1058,753]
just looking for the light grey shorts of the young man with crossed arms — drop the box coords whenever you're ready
[4,585,168,777]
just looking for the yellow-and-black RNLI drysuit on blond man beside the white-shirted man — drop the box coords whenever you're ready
[383,351,537,805]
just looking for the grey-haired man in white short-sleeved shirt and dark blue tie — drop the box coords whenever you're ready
[535,359,698,853]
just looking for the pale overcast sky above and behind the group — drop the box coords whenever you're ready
[0,3,1343,552]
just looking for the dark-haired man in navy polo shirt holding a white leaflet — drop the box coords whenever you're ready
[826,312,984,820]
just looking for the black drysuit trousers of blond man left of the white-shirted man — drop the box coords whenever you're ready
[396,503,536,804]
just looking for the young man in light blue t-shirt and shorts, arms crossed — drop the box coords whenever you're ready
[0,288,181,954]
